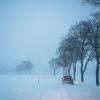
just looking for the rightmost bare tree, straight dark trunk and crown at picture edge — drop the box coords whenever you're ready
[88,11,100,85]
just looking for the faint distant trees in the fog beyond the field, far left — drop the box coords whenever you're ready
[0,60,34,74]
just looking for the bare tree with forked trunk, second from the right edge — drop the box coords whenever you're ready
[70,21,91,82]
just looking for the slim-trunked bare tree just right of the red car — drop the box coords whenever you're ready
[68,34,79,80]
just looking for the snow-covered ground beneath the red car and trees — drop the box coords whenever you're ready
[0,75,100,100]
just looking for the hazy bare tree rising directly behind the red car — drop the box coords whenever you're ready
[58,38,72,76]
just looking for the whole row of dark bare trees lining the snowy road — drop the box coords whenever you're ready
[50,11,100,85]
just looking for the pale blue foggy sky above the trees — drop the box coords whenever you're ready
[0,0,97,72]
